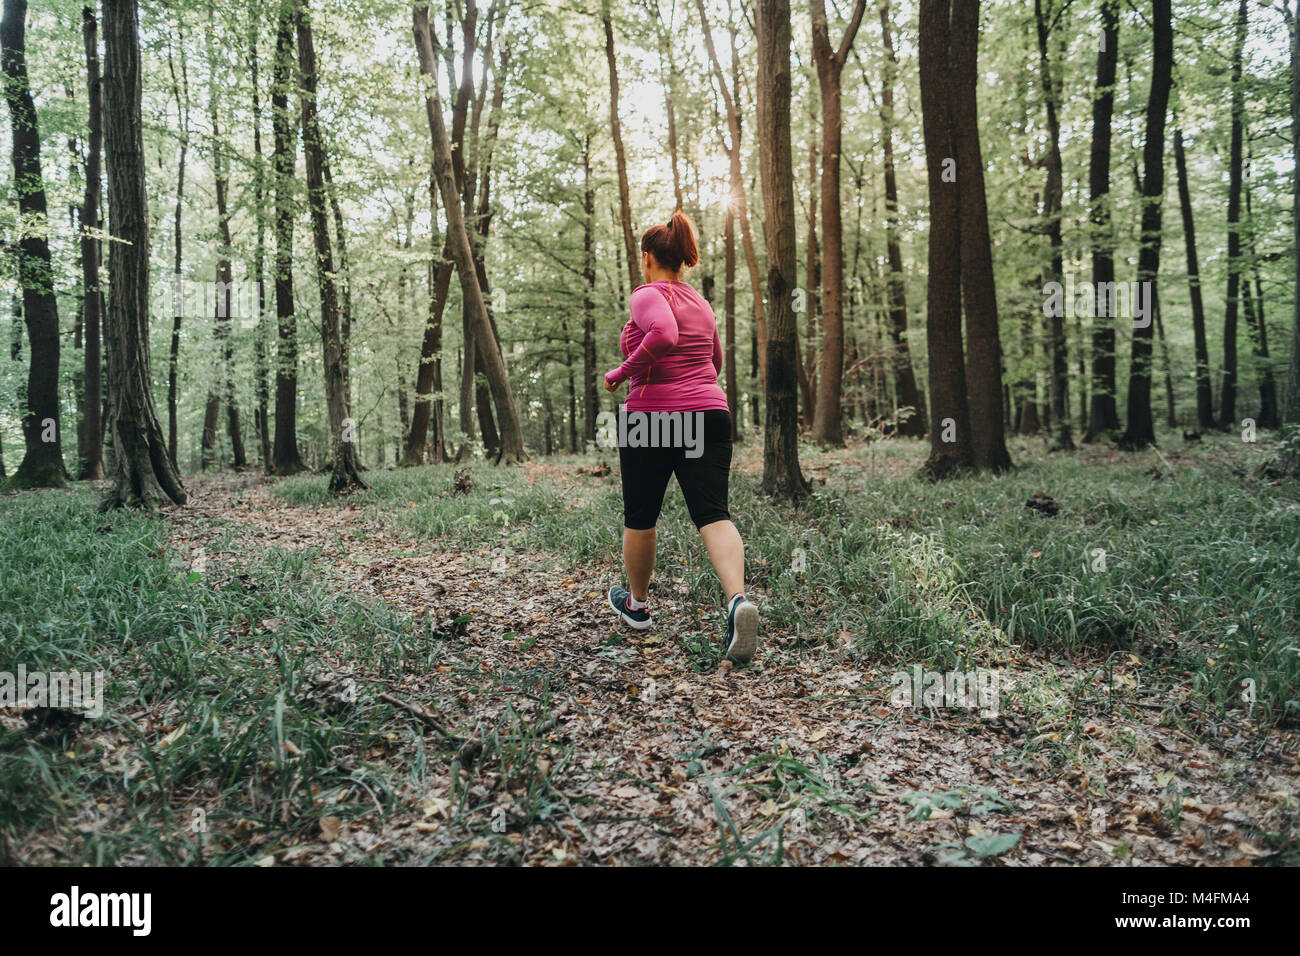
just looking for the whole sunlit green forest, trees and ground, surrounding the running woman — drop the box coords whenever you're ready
[0,0,1300,866]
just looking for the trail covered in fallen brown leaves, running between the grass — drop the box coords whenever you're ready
[172,483,1297,865]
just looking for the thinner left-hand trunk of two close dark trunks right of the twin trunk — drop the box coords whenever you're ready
[1083,0,1119,441]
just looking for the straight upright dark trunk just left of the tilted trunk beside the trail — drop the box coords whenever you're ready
[270,0,307,475]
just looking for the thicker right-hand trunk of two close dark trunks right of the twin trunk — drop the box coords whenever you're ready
[1119,0,1174,450]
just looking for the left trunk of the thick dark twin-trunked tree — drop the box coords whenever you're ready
[919,0,972,479]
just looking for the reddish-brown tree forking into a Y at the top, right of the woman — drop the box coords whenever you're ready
[813,0,867,445]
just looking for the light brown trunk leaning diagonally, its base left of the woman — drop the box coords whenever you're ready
[413,3,528,462]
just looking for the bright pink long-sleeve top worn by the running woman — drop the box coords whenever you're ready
[605,280,728,411]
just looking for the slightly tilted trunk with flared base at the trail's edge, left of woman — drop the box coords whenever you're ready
[296,0,367,494]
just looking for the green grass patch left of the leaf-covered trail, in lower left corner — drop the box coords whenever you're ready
[0,489,424,864]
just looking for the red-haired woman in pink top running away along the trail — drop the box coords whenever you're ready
[605,209,758,663]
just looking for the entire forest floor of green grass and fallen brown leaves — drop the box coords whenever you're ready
[0,438,1300,865]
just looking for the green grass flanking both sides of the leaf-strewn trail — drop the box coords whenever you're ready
[0,438,1300,864]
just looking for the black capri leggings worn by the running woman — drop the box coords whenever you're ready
[619,407,732,531]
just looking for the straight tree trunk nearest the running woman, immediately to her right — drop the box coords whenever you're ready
[754,0,809,498]
